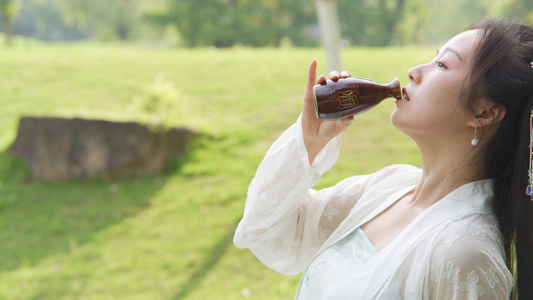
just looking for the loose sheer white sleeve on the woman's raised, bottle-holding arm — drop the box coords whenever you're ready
[234,119,374,275]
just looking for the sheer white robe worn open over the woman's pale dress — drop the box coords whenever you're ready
[234,119,512,299]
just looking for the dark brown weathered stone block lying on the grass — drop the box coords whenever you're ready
[10,117,196,181]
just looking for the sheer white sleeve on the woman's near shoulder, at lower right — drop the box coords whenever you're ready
[429,215,512,299]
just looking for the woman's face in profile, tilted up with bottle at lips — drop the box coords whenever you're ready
[391,30,478,143]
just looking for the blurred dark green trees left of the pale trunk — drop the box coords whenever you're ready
[152,0,316,47]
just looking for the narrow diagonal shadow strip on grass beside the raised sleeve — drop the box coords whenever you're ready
[172,218,241,300]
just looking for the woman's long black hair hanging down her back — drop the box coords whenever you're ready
[463,19,533,299]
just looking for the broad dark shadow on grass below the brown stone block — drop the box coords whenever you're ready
[0,150,166,273]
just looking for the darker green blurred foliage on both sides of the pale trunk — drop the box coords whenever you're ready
[156,0,405,47]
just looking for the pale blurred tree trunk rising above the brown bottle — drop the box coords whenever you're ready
[316,0,341,72]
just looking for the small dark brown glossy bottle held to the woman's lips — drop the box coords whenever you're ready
[313,77,403,120]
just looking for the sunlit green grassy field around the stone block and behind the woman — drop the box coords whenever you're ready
[0,43,434,299]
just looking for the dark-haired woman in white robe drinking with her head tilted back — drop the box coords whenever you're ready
[234,20,533,299]
